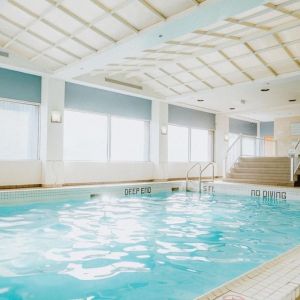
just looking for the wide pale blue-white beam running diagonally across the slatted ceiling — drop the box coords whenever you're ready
[54,0,268,78]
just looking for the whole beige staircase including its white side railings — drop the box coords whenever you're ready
[223,135,300,186]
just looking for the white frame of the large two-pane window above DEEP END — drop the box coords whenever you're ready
[64,108,151,164]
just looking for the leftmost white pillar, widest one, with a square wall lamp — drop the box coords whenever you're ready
[40,77,65,187]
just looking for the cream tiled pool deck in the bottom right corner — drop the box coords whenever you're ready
[196,245,300,300]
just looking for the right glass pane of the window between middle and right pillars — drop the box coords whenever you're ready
[191,128,212,161]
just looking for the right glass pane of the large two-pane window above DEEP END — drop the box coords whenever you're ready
[111,117,149,161]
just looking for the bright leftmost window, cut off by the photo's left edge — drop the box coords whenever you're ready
[0,101,39,160]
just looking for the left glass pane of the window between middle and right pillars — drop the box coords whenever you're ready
[168,125,189,161]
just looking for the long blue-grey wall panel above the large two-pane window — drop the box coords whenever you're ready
[65,82,152,120]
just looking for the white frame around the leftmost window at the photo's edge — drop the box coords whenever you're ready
[0,97,41,162]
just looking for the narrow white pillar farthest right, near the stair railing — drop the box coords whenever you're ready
[215,114,229,176]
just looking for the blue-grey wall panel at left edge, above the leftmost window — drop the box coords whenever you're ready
[0,68,41,103]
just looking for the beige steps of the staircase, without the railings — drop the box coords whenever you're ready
[224,156,292,186]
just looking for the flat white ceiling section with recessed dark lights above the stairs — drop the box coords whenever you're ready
[177,73,300,121]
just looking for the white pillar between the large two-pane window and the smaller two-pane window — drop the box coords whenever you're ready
[150,101,168,180]
